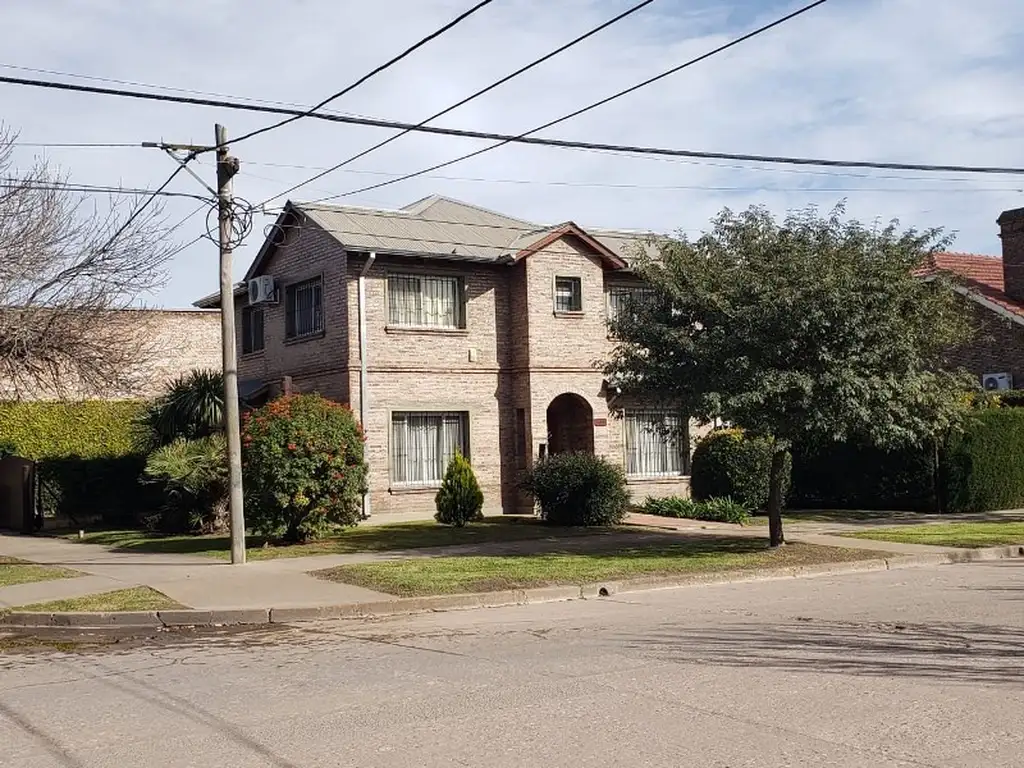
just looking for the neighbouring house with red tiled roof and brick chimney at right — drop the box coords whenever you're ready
[928,208,1024,389]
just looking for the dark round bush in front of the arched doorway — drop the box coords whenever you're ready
[525,454,630,525]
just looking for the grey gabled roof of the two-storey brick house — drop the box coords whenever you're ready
[233,195,645,288]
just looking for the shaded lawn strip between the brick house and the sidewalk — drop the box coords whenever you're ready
[72,516,607,560]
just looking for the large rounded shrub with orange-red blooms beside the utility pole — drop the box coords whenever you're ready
[242,394,367,542]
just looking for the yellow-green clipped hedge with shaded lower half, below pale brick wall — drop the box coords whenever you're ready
[0,400,154,523]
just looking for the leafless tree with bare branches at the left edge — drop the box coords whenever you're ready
[0,125,180,399]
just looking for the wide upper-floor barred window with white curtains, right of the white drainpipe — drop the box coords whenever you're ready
[387,274,466,329]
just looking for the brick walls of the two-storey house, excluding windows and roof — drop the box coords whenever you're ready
[237,214,688,514]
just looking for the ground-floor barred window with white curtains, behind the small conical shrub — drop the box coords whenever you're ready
[391,411,469,485]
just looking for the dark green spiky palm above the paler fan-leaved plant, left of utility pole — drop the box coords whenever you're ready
[142,369,224,447]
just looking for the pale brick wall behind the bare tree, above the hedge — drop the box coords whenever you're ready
[0,309,222,400]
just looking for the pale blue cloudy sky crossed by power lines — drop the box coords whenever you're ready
[0,0,1024,307]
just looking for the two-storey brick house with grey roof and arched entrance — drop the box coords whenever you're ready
[197,197,690,513]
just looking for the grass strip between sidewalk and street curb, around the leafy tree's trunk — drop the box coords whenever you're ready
[313,537,876,597]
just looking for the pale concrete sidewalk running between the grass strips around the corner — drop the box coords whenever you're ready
[0,512,1021,609]
